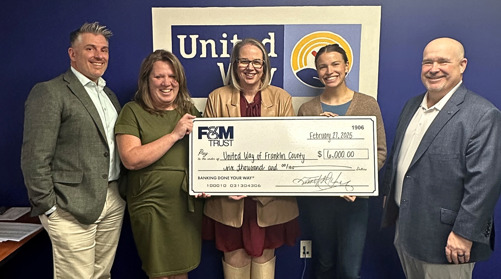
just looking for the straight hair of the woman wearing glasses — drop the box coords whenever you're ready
[229,38,271,91]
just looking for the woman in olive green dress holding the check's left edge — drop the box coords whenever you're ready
[115,50,203,279]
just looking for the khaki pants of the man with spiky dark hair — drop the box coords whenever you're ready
[40,182,125,279]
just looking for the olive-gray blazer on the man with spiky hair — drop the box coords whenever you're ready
[21,70,120,224]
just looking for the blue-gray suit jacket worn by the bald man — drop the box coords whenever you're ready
[382,85,501,264]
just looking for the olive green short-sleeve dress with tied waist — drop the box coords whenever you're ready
[115,102,203,277]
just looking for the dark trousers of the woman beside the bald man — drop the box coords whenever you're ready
[299,197,369,279]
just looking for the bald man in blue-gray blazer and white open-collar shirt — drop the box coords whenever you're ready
[383,38,501,278]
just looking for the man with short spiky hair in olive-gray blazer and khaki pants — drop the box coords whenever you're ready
[21,22,125,279]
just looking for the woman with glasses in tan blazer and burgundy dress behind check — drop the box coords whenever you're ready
[203,39,299,279]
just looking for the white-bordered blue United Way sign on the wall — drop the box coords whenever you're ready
[152,6,381,107]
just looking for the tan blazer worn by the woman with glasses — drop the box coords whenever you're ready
[204,85,299,228]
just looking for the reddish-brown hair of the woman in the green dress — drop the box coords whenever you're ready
[134,49,193,115]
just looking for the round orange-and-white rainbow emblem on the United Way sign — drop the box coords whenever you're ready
[291,31,353,88]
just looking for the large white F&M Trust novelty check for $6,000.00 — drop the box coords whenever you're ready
[189,116,378,196]
